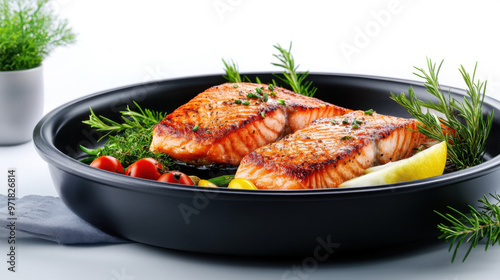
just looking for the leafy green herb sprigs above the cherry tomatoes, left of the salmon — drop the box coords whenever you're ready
[80,102,173,171]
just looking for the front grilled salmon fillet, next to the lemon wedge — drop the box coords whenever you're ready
[235,111,427,189]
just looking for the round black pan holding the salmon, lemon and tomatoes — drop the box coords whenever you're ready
[34,74,500,256]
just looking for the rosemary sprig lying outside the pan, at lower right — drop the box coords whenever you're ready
[436,193,500,262]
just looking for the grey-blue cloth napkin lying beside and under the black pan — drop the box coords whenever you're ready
[0,195,130,244]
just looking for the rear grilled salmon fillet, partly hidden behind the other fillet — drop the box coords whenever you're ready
[150,83,352,165]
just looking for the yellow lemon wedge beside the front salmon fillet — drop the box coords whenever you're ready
[339,141,447,188]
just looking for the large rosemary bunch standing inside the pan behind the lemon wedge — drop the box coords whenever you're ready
[391,59,494,170]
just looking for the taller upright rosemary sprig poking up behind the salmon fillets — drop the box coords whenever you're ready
[272,42,317,97]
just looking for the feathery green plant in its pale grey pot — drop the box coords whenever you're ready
[0,0,76,145]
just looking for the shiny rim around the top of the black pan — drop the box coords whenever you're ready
[33,72,500,199]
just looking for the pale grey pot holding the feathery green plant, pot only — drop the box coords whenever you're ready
[0,66,44,146]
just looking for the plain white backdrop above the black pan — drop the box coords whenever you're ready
[44,0,500,114]
